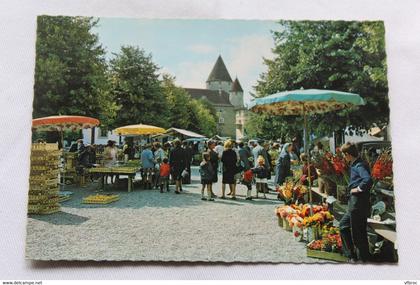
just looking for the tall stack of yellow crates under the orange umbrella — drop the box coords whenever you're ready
[28,143,61,214]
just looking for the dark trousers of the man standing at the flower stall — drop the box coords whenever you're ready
[340,205,370,262]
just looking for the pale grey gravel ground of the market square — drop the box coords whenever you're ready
[26,166,321,263]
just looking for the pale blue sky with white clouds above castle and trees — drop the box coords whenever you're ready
[94,18,278,101]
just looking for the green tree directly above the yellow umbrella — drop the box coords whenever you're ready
[110,46,170,128]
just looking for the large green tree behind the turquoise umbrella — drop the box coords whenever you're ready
[251,21,389,138]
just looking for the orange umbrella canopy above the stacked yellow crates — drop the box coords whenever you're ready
[32,115,100,131]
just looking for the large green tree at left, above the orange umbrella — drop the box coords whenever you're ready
[33,16,118,124]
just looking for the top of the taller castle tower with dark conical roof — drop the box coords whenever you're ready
[206,55,232,93]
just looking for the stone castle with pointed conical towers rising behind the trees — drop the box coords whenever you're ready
[185,55,246,140]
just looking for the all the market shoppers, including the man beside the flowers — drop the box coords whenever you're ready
[63,135,372,261]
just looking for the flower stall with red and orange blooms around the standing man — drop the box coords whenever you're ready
[276,148,398,262]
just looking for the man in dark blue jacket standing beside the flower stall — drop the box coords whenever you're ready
[340,143,373,262]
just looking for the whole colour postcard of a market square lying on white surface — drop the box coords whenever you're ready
[26,16,398,264]
